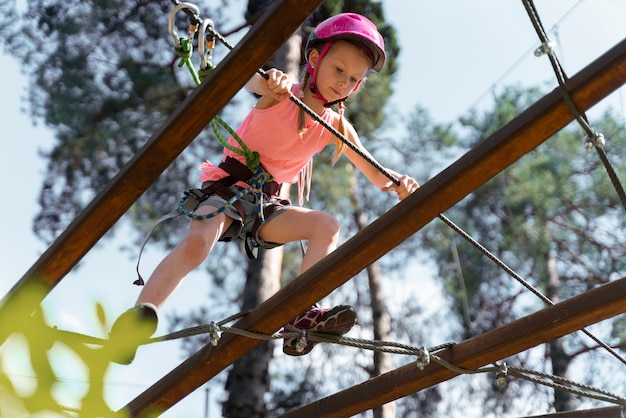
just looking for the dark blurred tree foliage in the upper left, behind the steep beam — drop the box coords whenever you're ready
[0,0,234,242]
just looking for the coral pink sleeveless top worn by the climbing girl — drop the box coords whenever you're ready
[200,85,339,202]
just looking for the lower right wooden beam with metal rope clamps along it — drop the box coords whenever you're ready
[281,278,626,418]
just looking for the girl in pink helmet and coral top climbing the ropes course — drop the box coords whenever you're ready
[110,13,419,364]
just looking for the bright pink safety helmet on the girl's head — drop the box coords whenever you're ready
[305,13,386,72]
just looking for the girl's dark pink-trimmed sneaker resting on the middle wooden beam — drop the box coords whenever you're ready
[282,305,356,356]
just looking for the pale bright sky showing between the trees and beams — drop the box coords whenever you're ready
[0,0,626,418]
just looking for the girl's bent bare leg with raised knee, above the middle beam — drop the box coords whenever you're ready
[259,206,339,273]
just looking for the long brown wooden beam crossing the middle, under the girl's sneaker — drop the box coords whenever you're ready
[120,36,626,416]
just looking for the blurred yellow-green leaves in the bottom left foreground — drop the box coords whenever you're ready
[0,285,128,418]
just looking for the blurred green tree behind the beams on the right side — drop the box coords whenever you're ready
[412,88,626,412]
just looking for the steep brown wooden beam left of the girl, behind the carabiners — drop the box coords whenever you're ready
[0,0,322,324]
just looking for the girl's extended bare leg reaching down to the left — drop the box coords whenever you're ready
[137,206,232,308]
